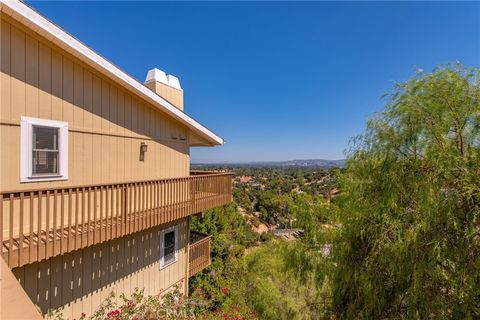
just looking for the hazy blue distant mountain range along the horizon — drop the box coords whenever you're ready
[192,159,345,168]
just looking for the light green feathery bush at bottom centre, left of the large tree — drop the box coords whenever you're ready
[223,240,332,320]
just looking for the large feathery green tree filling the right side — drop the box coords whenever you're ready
[332,65,480,319]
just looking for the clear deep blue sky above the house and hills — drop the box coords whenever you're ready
[30,2,480,162]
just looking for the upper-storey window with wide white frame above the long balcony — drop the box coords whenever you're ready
[20,117,68,182]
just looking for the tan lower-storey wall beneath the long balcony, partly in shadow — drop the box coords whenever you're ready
[12,219,188,319]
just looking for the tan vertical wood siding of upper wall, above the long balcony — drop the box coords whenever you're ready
[0,15,189,190]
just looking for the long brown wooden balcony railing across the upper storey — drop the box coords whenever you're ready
[0,173,232,268]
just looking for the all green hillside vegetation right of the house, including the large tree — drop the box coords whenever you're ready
[191,65,480,319]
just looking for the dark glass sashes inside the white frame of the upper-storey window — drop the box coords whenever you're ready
[32,126,59,175]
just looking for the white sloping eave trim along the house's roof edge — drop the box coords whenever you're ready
[0,0,223,145]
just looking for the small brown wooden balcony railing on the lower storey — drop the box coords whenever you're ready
[188,231,211,277]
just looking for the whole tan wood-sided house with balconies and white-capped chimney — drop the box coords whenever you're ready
[0,0,232,319]
